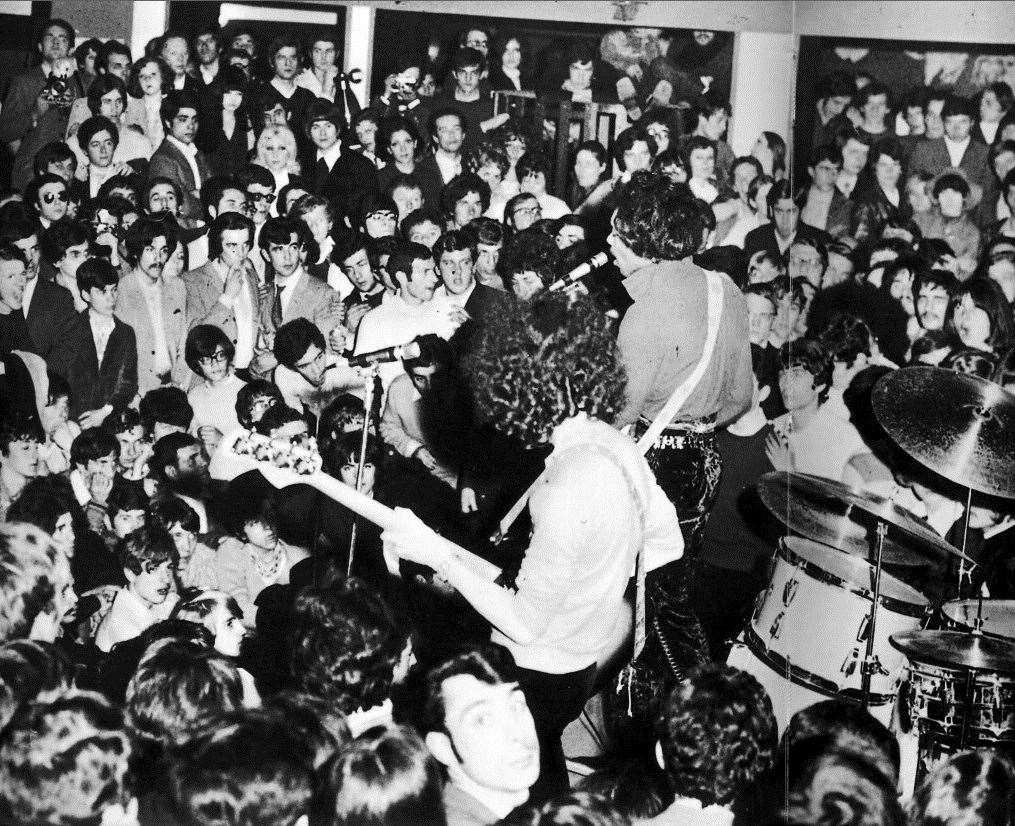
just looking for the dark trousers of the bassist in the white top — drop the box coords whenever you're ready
[518,664,596,803]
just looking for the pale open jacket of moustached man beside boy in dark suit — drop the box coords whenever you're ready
[115,272,192,396]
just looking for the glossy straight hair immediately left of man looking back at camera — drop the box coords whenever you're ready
[311,726,446,826]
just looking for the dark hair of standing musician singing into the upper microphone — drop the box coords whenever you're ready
[613,171,705,261]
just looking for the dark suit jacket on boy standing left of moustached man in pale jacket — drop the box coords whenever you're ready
[54,309,137,424]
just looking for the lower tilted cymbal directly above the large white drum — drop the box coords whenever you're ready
[758,471,971,566]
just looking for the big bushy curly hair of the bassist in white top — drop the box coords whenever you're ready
[466,293,627,446]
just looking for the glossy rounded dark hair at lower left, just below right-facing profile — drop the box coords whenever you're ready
[125,638,244,746]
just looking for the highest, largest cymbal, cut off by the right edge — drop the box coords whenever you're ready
[872,366,1015,499]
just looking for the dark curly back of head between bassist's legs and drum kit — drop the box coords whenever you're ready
[659,664,777,806]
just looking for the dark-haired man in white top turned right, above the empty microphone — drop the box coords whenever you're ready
[355,242,467,392]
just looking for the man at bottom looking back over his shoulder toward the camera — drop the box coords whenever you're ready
[420,645,539,826]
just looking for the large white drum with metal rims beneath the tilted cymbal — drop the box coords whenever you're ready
[744,537,928,704]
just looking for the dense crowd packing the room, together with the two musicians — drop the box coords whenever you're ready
[0,12,1015,826]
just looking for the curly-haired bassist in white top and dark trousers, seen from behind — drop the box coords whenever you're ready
[383,294,683,802]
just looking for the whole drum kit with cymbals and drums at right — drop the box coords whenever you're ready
[728,366,1015,779]
